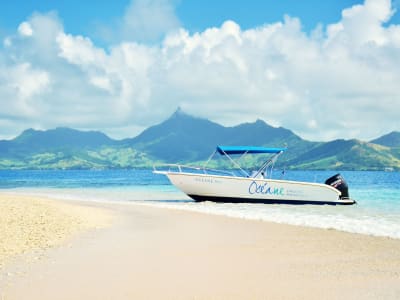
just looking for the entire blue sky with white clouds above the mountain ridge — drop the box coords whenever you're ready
[0,0,400,140]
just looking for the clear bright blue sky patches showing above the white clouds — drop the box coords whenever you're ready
[0,0,400,45]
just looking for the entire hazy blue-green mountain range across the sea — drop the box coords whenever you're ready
[0,109,400,170]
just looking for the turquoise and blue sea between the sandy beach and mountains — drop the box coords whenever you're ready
[0,169,400,239]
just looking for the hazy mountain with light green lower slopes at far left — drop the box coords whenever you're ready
[0,128,155,169]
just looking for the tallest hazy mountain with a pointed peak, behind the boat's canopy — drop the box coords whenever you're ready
[122,109,312,162]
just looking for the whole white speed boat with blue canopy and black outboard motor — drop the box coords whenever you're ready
[154,146,355,205]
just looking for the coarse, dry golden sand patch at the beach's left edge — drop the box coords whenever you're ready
[0,192,112,270]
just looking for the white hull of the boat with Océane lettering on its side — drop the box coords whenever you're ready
[163,172,355,204]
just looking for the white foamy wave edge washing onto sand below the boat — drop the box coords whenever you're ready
[141,202,400,239]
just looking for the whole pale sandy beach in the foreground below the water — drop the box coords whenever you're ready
[0,194,400,300]
